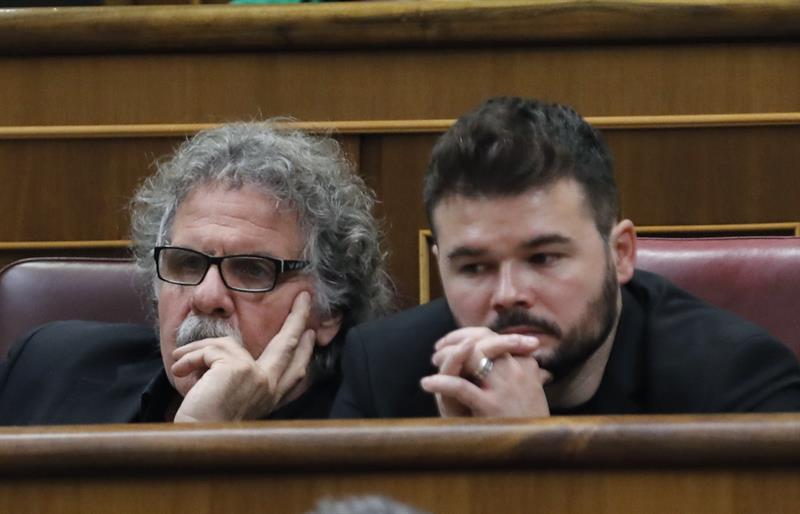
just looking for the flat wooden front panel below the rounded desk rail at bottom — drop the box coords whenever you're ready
[0,468,800,514]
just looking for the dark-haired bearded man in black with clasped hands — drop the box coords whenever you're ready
[333,98,800,417]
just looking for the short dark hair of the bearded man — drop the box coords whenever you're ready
[423,97,619,239]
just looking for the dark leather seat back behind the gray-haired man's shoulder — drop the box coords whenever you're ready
[0,257,151,360]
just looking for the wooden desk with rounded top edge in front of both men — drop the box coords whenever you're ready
[0,414,800,514]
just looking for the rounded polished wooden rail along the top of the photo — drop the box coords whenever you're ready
[0,0,800,54]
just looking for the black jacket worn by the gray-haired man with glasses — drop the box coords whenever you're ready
[0,321,338,425]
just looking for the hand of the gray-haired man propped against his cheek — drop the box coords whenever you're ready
[171,292,316,422]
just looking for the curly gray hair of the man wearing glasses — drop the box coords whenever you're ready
[131,120,393,378]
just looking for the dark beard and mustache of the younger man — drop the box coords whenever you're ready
[489,255,619,381]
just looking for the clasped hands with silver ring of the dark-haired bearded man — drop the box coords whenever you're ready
[421,327,550,417]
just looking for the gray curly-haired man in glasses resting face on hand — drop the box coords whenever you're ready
[0,123,390,424]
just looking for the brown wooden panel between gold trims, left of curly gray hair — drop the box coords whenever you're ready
[0,138,177,241]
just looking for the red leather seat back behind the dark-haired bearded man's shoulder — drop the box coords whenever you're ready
[637,237,800,356]
